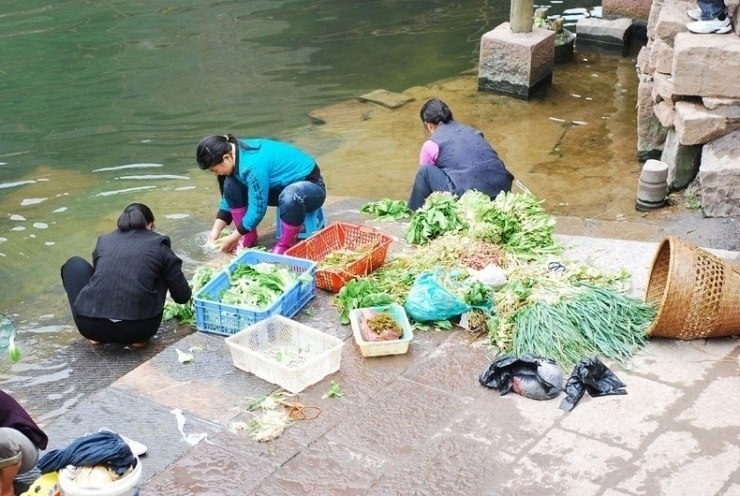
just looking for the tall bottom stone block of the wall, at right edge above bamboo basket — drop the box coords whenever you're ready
[698,131,740,217]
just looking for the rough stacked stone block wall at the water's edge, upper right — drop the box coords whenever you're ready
[637,0,740,217]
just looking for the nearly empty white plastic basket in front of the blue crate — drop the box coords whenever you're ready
[225,314,344,394]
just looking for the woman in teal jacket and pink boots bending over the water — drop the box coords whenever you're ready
[196,134,326,255]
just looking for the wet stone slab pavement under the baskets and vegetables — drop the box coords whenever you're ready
[15,203,740,496]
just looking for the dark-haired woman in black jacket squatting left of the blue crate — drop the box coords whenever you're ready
[62,203,192,346]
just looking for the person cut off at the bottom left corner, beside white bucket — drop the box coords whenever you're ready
[0,390,49,496]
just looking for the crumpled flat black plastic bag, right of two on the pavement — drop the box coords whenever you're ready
[560,357,627,412]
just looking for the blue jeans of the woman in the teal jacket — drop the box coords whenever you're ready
[223,176,326,226]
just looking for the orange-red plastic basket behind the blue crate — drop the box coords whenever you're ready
[285,222,393,293]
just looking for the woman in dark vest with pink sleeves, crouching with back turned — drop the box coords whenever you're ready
[407,99,514,210]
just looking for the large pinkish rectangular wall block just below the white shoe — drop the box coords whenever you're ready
[671,33,740,98]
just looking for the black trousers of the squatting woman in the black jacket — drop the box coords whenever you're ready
[62,257,162,344]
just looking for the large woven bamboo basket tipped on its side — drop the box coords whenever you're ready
[645,237,740,339]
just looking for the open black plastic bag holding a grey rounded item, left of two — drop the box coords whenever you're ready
[478,354,563,400]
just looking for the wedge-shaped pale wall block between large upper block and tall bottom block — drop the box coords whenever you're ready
[675,102,740,148]
